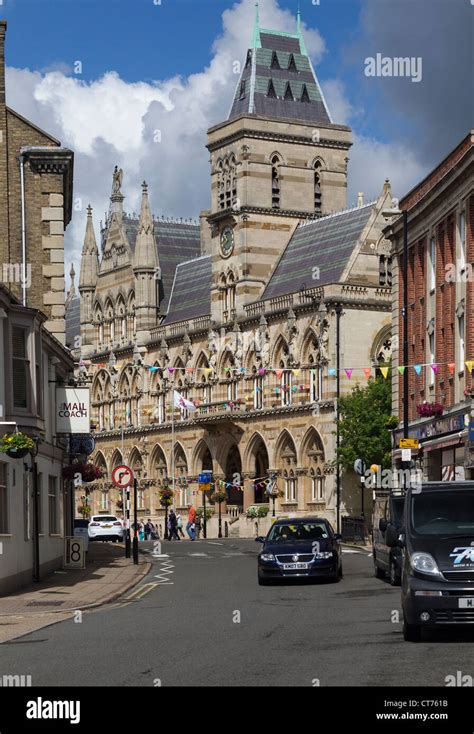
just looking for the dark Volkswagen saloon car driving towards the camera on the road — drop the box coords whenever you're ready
[255,517,342,586]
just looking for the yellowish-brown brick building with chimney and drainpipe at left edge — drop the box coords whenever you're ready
[0,20,73,344]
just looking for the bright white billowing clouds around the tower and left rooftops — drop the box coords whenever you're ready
[1,0,428,280]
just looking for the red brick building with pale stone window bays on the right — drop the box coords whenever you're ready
[385,130,474,480]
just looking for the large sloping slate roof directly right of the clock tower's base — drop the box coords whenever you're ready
[261,203,375,300]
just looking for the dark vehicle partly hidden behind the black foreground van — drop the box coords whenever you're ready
[372,492,405,586]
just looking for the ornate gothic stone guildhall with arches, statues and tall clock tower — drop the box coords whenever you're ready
[69,14,391,536]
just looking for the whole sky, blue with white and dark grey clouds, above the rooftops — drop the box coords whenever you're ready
[0,0,474,271]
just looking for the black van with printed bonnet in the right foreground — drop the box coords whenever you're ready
[387,481,474,642]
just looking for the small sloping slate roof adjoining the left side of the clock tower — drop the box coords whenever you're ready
[162,255,212,324]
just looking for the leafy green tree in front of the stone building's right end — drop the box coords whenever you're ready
[339,377,398,469]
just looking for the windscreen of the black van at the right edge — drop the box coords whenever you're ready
[410,489,474,535]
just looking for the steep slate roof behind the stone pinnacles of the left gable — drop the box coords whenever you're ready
[123,216,201,311]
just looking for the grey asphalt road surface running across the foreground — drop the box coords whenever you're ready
[0,538,474,688]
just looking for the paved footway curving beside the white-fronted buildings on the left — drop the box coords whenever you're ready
[0,542,151,643]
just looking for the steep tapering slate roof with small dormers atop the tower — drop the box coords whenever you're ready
[229,29,332,124]
